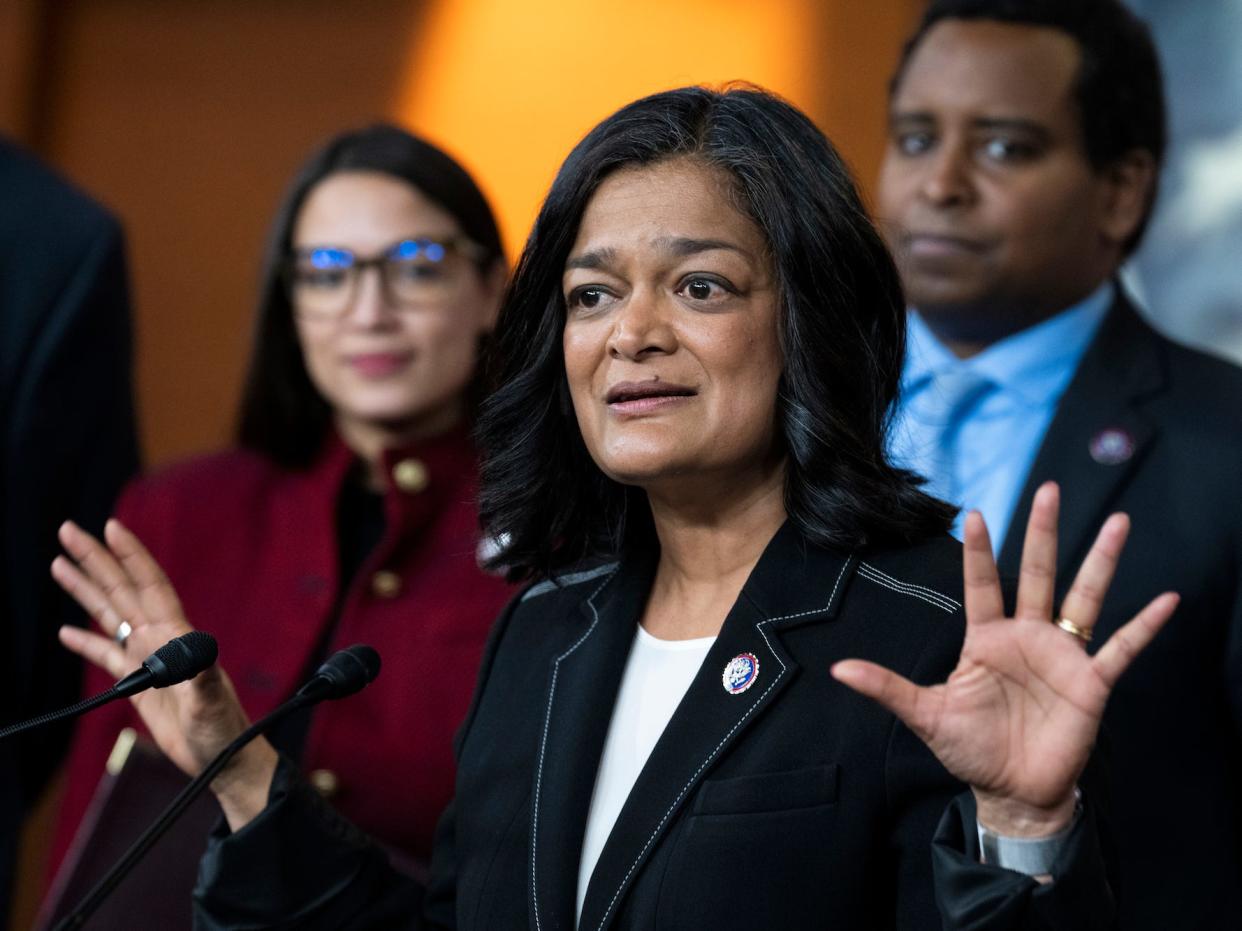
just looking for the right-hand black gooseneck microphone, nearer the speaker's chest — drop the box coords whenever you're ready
[53,643,380,931]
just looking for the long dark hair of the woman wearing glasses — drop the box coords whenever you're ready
[237,124,504,468]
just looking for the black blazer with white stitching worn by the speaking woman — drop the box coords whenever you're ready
[197,524,1110,931]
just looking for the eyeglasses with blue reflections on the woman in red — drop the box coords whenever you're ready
[284,237,483,317]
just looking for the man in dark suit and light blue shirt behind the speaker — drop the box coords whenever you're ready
[878,0,1242,929]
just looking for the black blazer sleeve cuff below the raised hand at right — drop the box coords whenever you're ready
[932,792,1115,931]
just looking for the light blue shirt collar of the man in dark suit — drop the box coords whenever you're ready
[902,276,1114,406]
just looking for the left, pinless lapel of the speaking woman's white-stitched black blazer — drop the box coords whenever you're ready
[530,560,655,931]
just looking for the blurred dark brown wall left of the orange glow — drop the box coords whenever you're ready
[0,0,417,463]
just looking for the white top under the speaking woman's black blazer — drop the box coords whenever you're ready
[574,624,715,926]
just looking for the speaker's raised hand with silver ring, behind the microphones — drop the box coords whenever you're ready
[52,520,277,830]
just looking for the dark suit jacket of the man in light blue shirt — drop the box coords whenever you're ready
[1000,288,1242,931]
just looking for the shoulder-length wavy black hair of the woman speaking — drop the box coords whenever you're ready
[477,86,955,580]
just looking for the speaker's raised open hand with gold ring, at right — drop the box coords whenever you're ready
[832,483,1177,837]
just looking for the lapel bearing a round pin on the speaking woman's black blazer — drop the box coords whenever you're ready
[574,524,848,931]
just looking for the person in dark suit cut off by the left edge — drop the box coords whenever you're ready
[0,139,138,925]
